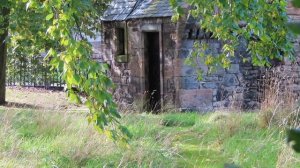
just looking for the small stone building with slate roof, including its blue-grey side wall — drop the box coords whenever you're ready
[94,0,299,111]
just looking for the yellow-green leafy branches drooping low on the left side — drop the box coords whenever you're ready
[0,0,130,142]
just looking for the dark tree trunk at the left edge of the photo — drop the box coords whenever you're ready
[0,2,9,105]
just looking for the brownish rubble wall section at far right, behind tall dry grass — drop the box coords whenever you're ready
[259,4,300,105]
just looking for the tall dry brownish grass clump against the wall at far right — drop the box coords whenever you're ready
[260,69,300,128]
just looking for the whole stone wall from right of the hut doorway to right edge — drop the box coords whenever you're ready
[175,4,300,111]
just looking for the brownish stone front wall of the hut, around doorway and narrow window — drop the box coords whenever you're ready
[101,18,176,109]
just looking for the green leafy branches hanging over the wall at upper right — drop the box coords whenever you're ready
[171,0,295,72]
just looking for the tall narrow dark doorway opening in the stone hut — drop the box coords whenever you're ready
[144,32,161,112]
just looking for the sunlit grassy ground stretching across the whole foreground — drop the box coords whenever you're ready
[0,89,300,168]
